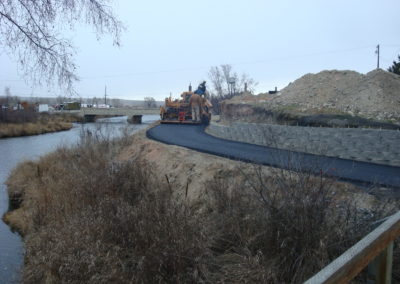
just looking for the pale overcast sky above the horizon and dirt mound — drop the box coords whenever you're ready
[0,0,400,100]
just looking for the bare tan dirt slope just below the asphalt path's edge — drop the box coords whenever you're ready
[119,131,376,208]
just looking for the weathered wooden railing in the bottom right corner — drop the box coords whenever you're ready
[305,211,400,284]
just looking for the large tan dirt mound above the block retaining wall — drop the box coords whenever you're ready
[268,69,400,122]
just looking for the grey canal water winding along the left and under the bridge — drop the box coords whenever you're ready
[0,115,159,283]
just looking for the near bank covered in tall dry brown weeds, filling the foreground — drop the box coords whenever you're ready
[5,129,398,283]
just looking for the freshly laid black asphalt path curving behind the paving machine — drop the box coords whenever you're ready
[147,124,400,188]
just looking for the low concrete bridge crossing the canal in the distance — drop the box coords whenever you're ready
[76,108,160,123]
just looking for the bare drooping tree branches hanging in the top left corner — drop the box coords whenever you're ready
[0,0,123,91]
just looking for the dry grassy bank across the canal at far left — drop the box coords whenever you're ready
[0,114,80,138]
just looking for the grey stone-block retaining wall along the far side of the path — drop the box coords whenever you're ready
[206,122,400,167]
